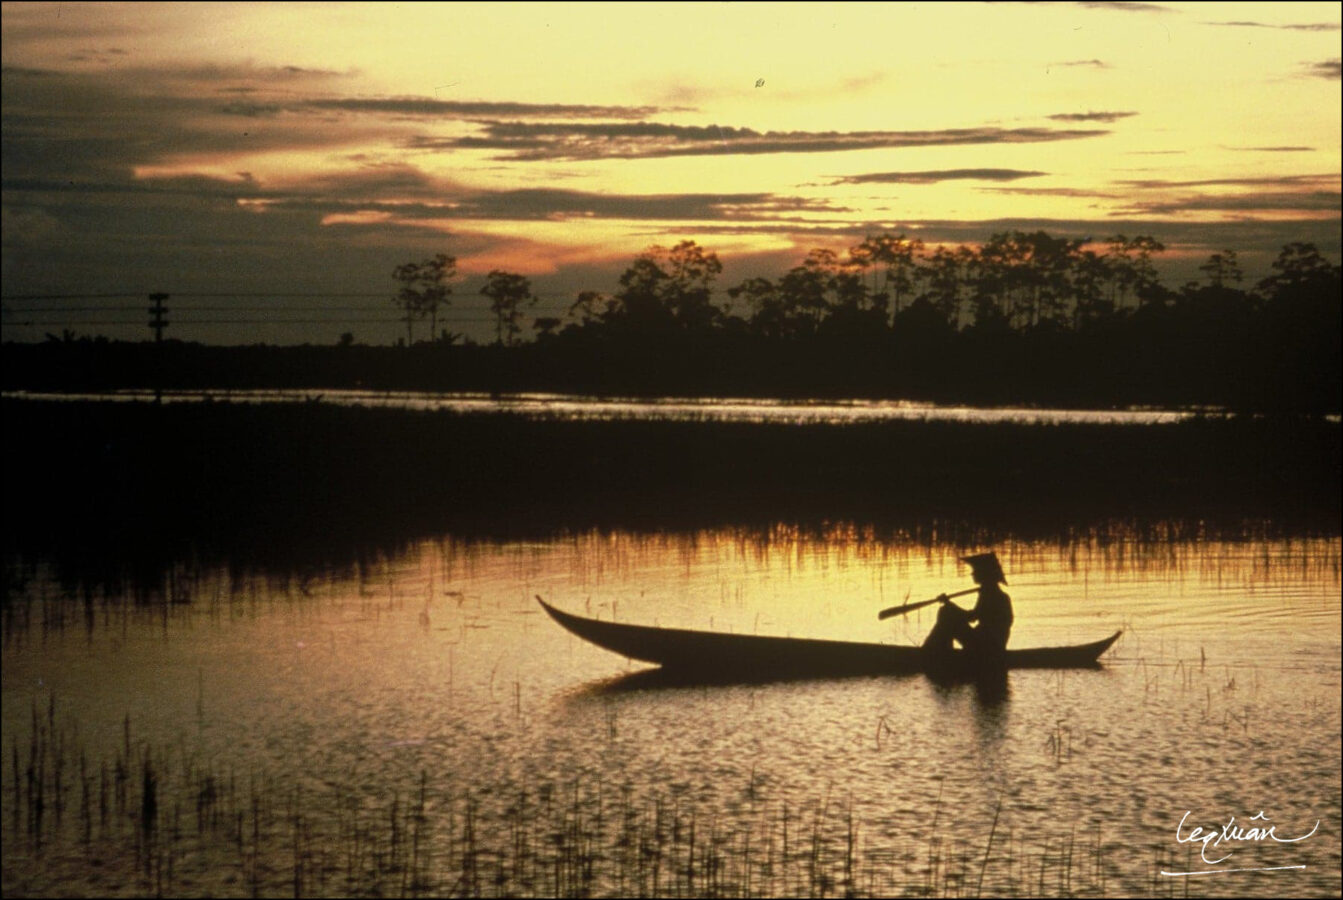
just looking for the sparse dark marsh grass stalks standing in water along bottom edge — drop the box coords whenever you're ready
[0,697,1149,897]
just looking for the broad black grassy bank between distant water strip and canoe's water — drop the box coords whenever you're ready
[3,399,1340,585]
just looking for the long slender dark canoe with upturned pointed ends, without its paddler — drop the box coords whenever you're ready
[536,596,1121,676]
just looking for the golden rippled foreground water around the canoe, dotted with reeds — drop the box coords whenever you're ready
[0,527,1343,896]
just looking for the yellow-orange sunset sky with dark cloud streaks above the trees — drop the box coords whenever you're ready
[3,3,1343,343]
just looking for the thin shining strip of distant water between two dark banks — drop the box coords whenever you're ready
[4,388,1230,424]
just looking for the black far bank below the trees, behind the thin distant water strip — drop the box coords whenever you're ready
[0,324,1340,415]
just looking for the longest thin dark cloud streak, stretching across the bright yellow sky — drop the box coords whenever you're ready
[408,122,1109,160]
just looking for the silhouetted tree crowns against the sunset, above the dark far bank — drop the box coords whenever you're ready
[393,231,1339,344]
